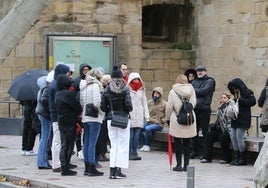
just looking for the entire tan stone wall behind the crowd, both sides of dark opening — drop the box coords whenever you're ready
[0,0,268,126]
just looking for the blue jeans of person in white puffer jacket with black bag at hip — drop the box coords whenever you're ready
[83,122,101,164]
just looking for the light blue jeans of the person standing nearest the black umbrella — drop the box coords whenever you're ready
[36,115,52,167]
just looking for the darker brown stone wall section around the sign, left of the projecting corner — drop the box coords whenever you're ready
[0,0,195,117]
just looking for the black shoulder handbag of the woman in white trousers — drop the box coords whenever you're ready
[109,96,129,129]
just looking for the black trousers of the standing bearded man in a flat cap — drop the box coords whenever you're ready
[192,110,211,153]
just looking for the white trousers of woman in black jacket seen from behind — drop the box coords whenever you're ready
[107,120,130,168]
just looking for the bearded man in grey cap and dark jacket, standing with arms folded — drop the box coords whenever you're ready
[190,65,216,159]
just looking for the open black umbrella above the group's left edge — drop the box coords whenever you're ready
[8,69,48,101]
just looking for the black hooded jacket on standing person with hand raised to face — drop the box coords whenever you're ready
[228,78,256,129]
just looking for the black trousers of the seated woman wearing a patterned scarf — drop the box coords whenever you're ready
[203,130,231,162]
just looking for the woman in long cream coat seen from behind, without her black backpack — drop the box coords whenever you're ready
[165,74,197,171]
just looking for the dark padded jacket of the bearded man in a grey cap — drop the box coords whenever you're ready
[192,75,215,111]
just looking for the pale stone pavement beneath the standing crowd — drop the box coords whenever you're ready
[0,135,255,188]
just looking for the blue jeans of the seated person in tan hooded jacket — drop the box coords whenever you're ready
[140,123,163,146]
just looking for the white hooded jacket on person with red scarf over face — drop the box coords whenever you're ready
[128,72,150,128]
